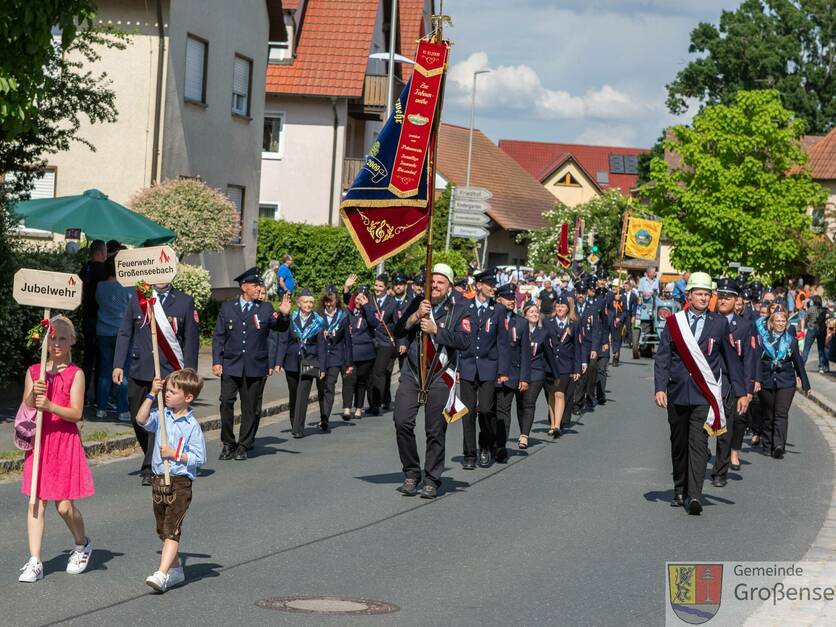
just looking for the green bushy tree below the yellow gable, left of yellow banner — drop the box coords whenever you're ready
[517,190,631,270]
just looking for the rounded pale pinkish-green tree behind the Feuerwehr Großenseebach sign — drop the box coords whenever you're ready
[128,179,240,259]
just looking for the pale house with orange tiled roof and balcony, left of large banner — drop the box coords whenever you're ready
[259,0,432,225]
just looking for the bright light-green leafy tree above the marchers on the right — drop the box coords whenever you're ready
[641,90,826,279]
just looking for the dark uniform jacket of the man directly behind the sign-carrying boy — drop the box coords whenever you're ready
[113,287,200,381]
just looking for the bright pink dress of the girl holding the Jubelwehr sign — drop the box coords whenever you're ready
[20,364,95,501]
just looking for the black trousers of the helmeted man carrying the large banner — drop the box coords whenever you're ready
[394,366,449,486]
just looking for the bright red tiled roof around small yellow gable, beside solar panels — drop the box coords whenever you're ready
[499,139,647,195]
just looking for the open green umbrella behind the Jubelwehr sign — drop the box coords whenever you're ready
[13,189,177,246]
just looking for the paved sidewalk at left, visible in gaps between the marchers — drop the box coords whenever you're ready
[0,347,320,475]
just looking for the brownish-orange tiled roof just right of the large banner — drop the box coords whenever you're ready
[438,124,556,231]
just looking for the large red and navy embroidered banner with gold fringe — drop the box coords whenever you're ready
[340,41,448,267]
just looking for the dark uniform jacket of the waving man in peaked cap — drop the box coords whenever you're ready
[212,298,289,377]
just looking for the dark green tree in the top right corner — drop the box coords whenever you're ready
[667,0,836,133]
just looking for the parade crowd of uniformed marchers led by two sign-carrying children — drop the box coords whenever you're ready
[16,257,830,592]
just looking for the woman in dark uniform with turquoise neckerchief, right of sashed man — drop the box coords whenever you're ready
[755,304,810,459]
